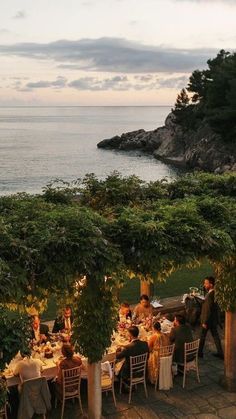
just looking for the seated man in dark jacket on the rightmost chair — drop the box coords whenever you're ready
[170,314,193,364]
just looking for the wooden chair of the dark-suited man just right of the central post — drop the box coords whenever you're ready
[120,353,148,404]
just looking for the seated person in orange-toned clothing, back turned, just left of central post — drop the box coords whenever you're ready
[56,343,82,391]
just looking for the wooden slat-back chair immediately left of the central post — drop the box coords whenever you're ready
[55,367,83,419]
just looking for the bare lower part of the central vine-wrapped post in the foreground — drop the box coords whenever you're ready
[88,362,102,419]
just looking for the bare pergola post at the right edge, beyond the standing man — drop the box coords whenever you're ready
[221,311,236,392]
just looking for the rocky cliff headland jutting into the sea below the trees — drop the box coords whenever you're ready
[97,113,236,173]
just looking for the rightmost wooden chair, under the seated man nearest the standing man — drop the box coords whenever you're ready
[178,339,200,388]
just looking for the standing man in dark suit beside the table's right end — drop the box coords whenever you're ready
[198,276,224,359]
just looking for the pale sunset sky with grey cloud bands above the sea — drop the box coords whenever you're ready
[0,0,236,106]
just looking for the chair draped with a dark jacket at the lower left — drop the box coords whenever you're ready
[17,377,51,419]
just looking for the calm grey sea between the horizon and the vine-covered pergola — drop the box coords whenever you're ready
[0,107,176,195]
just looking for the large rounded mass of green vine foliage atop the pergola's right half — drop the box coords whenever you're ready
[108,198,234,279]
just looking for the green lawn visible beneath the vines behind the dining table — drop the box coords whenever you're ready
[42,262,213,321]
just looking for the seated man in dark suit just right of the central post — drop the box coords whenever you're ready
[116,326,149,379]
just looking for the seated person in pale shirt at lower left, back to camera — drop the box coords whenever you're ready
[13,353,43,381]
